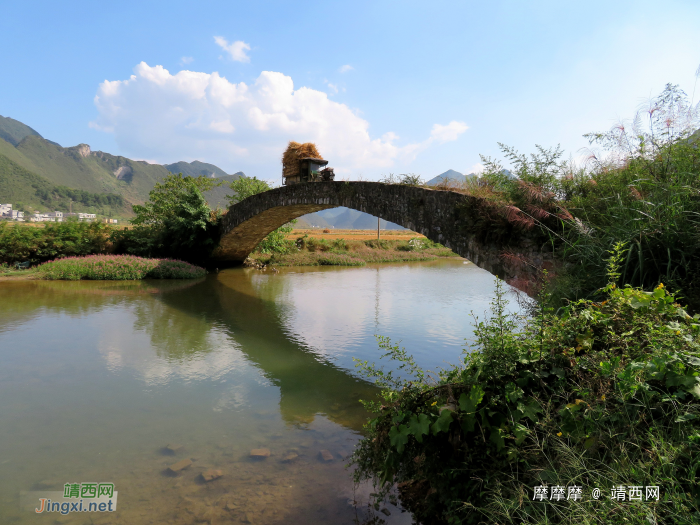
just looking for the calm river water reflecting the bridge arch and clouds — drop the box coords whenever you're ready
[0,260,520,525]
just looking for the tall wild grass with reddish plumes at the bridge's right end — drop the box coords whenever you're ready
[424,85,700,311]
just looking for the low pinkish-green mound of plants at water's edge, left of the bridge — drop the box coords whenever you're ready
[37,255,207,281]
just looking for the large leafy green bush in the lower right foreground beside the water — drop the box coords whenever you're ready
[353,245,700,525]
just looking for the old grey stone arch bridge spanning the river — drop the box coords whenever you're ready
[214,181,552,289]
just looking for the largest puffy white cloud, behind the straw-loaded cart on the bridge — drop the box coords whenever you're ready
[90,62,467,172]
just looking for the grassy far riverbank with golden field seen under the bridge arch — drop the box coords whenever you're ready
[247,236,459,267]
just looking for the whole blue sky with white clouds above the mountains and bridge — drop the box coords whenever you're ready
[0,0,700,180]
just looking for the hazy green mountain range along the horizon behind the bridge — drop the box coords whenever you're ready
[0,115,465,229]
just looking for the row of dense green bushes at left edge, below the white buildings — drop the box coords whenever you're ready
[0,222,112,264]
